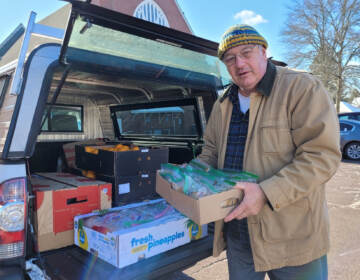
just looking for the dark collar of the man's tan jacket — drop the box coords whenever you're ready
[220,60,276,103]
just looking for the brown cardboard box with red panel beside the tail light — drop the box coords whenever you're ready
[31,173,111,252]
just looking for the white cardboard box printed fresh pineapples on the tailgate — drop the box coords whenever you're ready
[74,199,207,268]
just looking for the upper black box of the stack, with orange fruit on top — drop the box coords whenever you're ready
[75,145,169,176]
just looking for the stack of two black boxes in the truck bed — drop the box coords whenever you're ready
[75,145,169,207]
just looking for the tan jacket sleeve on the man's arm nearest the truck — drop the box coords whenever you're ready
[198,101,221,168]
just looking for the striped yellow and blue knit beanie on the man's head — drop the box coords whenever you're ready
[218,24,268,59]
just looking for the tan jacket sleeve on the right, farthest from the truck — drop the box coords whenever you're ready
[260,73,341,211]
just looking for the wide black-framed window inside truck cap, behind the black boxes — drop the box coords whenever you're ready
[116,105,198,136]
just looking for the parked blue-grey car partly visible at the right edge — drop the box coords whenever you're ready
[339,120,360,160]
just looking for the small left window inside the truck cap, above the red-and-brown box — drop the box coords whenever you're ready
[41,105,83,132]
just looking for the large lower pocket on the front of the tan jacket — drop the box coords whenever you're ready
[260,198,314,243]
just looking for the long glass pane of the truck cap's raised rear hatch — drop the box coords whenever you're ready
[67,18,230,85]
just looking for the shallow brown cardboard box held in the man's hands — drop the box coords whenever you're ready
[156,172,243,225]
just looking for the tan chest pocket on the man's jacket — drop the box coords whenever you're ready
[260,122,294,154]
